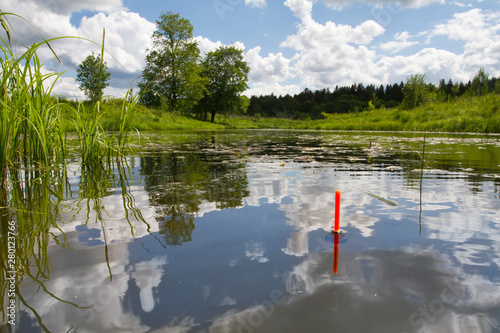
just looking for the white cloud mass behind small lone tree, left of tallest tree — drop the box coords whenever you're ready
[0,0,155,98]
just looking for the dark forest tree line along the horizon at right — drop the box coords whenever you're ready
[247,68,500,119]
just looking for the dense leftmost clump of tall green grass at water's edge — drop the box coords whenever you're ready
[0,12,66,179]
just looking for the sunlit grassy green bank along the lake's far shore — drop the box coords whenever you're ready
[90,94,500,133]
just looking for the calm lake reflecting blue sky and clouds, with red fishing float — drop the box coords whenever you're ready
[0,130,500,333]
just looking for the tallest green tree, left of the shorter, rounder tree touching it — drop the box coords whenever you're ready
[139,11,206,111]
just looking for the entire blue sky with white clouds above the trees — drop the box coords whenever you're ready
[0,0,500,98]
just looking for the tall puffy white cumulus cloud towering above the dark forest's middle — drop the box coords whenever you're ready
[281,0,385,89]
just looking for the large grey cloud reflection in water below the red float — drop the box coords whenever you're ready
[209,248,497,333]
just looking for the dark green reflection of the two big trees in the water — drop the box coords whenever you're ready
[141,145,249,245]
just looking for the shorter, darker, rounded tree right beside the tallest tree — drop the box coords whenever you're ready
[197,46,250,123]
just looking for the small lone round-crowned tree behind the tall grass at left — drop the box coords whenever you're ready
[76,52,111,102]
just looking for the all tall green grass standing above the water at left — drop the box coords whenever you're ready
[0,11,139,179]
